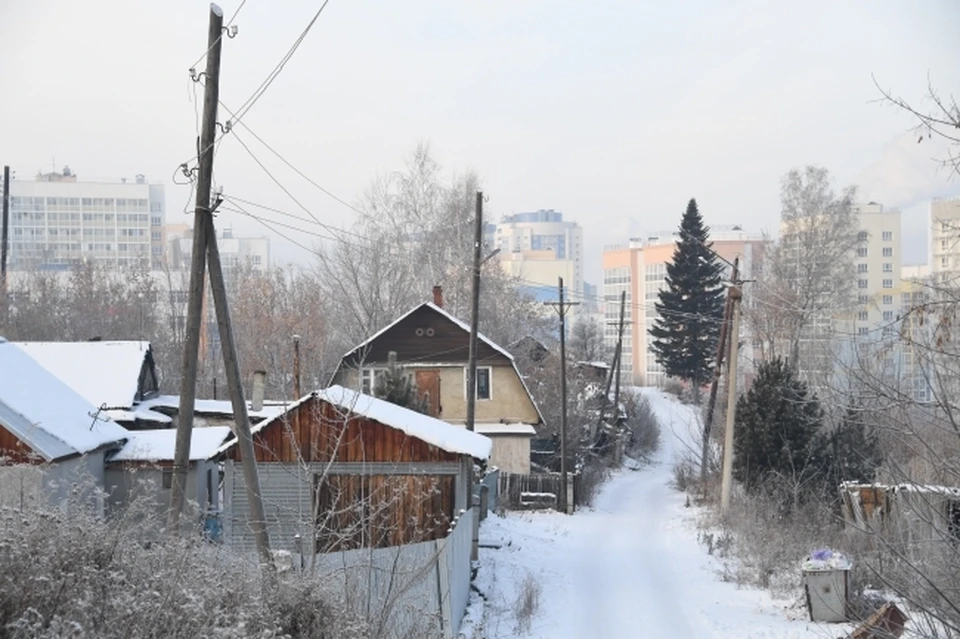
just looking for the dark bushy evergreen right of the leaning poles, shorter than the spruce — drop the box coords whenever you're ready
[733,358,823,497]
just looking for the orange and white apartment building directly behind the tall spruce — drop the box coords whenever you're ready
[603,226,763,386]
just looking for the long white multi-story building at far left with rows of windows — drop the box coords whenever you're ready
[3,167,165,270]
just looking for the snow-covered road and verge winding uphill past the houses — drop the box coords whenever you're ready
[477,389,849,639]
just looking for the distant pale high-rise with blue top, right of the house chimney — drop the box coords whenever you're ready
[493,209,583,308]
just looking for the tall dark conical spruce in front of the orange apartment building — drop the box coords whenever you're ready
[650,199,724,397]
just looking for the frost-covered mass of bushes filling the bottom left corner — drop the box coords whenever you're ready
[0,488,371,638]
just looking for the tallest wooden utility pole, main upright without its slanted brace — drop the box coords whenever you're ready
[169,4,223,534]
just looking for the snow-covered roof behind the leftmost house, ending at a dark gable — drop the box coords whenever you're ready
[16,341,150,408]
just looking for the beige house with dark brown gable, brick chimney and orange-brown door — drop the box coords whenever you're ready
[333,296,543,474]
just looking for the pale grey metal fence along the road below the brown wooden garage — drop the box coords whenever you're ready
[302,509,476,639]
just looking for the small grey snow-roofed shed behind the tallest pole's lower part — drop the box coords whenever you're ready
[104,426,231,514]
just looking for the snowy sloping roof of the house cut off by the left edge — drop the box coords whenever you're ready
[0,338,129,461]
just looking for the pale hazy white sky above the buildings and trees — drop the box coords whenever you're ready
[0,0,960,282]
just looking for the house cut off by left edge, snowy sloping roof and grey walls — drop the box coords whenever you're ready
[0,338,129,514]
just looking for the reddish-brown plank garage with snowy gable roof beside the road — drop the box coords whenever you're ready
[219,386,491,555]
